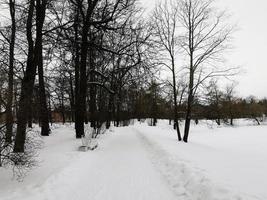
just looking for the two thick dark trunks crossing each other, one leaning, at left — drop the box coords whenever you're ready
[14,0,49,152]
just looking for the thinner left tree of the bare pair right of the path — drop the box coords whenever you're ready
[152,1,182,141]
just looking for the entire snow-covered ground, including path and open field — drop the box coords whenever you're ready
[0,121,267,200]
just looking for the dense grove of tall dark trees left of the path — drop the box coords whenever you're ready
[0,0,153,152]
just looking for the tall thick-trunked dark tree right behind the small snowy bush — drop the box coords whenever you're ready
[72,0,140,138]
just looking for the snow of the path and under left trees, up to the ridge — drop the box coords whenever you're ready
[0,124,175,200]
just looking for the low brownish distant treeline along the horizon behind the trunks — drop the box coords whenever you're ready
[0,84,267,126]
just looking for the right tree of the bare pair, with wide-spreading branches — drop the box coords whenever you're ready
[178,0,237,142]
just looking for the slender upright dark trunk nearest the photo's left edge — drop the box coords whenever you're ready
[5,0,16,143]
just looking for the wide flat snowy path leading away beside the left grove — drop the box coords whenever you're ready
[0,128,177,200]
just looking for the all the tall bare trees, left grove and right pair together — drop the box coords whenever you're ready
[0,0,241,156]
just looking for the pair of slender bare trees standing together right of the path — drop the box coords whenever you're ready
[152,0,237,142]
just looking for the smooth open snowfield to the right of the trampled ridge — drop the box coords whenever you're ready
[137,120,267,199]
